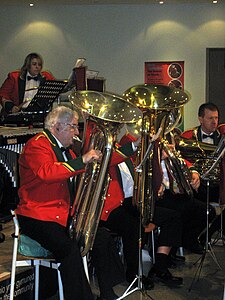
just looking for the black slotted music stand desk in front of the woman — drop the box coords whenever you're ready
[21,80,68,113]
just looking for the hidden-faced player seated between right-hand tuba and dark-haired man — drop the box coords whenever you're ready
[156,145,215,254]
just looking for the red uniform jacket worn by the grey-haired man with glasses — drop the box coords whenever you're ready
[16,130,136,226]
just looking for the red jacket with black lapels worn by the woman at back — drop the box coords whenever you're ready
[0,70,55,106]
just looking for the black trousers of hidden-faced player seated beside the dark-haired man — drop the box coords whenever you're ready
[156,190,215,249]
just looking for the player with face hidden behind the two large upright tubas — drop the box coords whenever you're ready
[100,134,183,289]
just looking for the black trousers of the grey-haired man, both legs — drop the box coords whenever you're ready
[18,215,124,300]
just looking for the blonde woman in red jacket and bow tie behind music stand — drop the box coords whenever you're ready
[0,53,55,114]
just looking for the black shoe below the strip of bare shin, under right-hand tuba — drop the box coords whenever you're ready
[148,267,183,287]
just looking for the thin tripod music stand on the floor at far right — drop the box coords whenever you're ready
[188,180,222,292]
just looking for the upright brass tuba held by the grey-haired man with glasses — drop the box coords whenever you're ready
[69,91,142,256]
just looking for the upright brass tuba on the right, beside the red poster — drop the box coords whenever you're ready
[124,84,189,226]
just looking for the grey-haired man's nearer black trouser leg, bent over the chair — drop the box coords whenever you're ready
[18,215,94,300]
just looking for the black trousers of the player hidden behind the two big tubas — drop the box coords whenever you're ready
[101,198,182,277]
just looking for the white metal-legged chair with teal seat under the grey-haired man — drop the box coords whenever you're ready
[9,211,64,300]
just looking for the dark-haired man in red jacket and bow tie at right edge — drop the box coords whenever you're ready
[181,102,225,241]
